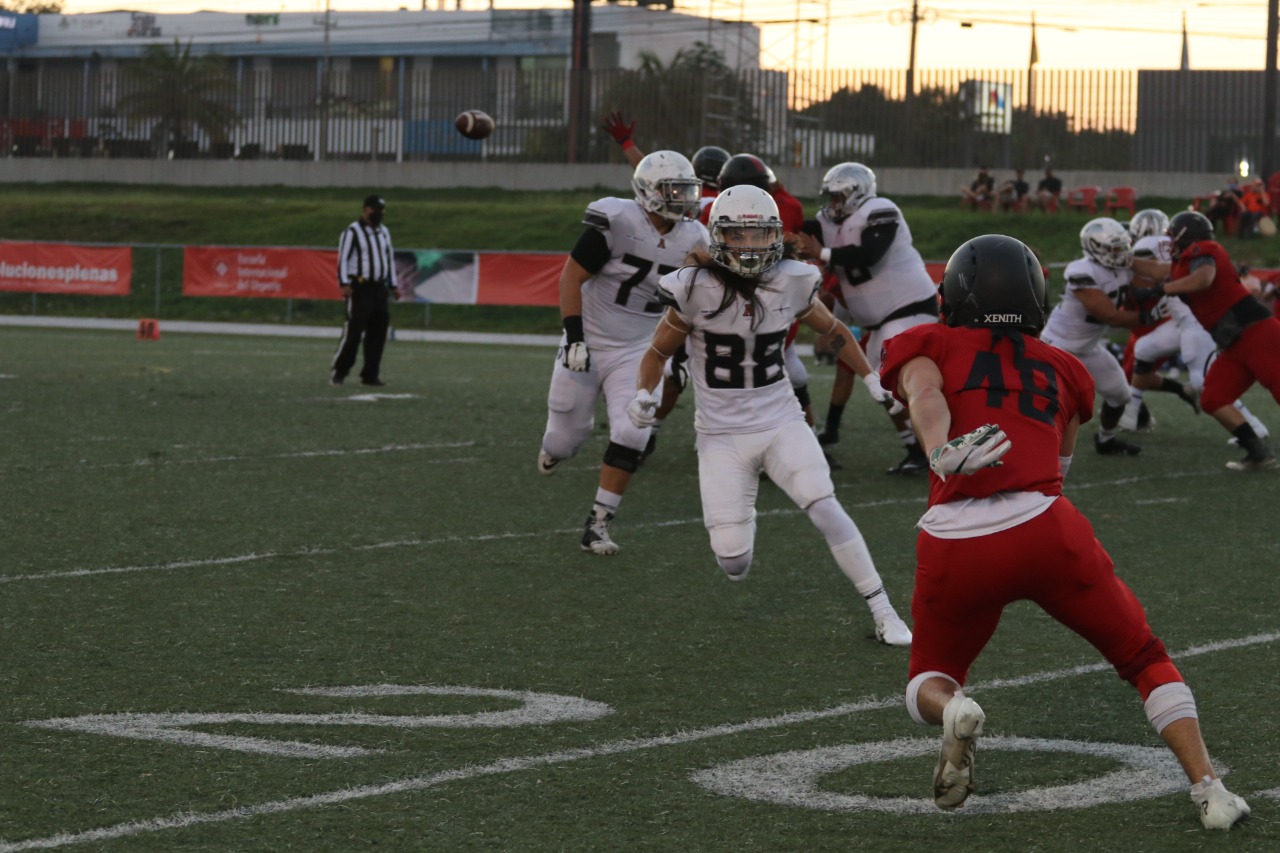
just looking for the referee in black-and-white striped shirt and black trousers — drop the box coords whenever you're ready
[329,195,396,386]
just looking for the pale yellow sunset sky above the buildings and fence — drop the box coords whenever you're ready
[57,0,1267,70]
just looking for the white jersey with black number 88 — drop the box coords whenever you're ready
[658,260,822,433]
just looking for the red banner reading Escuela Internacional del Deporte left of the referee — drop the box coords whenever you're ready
[182,246,342,300]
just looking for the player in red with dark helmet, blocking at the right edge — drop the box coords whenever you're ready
[1135,210,1280,471]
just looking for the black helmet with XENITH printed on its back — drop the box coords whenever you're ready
[942,234,1048,333]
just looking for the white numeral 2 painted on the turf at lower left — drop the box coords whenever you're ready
[24,684,613,758]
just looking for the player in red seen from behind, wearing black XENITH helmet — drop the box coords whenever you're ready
[882,234,1249,830]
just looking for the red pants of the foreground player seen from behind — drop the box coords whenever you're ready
[910,497,1180,697]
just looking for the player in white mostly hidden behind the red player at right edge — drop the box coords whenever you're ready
[1120,209,1271,438]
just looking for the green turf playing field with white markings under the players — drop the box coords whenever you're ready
[0,329,1280,853]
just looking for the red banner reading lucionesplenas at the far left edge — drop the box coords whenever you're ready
[0,242,133,296]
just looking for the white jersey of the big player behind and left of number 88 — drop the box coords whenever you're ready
[582,197,708,350]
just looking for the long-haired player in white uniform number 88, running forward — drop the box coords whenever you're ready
[627,184,911,646]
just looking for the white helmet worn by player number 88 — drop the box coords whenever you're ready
[708,183,783,278]
